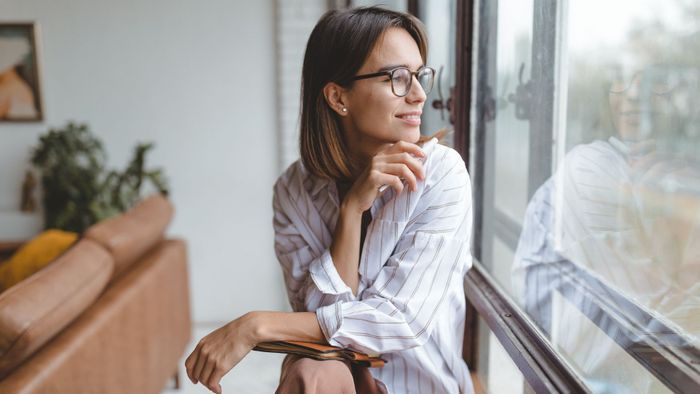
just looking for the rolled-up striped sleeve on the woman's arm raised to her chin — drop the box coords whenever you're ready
[273,178,356,312]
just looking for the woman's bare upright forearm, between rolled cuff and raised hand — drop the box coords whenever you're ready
[330,204,362,294]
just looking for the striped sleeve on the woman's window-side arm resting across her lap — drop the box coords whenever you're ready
[316,151,472,354]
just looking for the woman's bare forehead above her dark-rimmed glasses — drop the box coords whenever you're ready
[360,28,423,72]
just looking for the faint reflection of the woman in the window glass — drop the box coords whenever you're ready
[513,63,700,393]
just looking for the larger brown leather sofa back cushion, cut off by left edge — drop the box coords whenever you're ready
[0,239,114,379]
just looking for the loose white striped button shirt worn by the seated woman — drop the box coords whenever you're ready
[273,143,473,393]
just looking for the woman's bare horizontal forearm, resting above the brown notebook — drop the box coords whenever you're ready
[249,311,328,344]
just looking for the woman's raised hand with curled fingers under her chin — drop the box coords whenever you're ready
[343,141,425,213]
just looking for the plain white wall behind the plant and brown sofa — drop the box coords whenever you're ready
[0,0,286,322]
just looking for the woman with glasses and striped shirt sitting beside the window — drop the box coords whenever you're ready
[185,8,472,393]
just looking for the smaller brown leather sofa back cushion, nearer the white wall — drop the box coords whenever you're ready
[84,195,173,281]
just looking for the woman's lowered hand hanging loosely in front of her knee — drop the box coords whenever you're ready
[185,314,256,394]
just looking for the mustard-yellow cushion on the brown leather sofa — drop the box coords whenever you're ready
[0,230,78,292]
